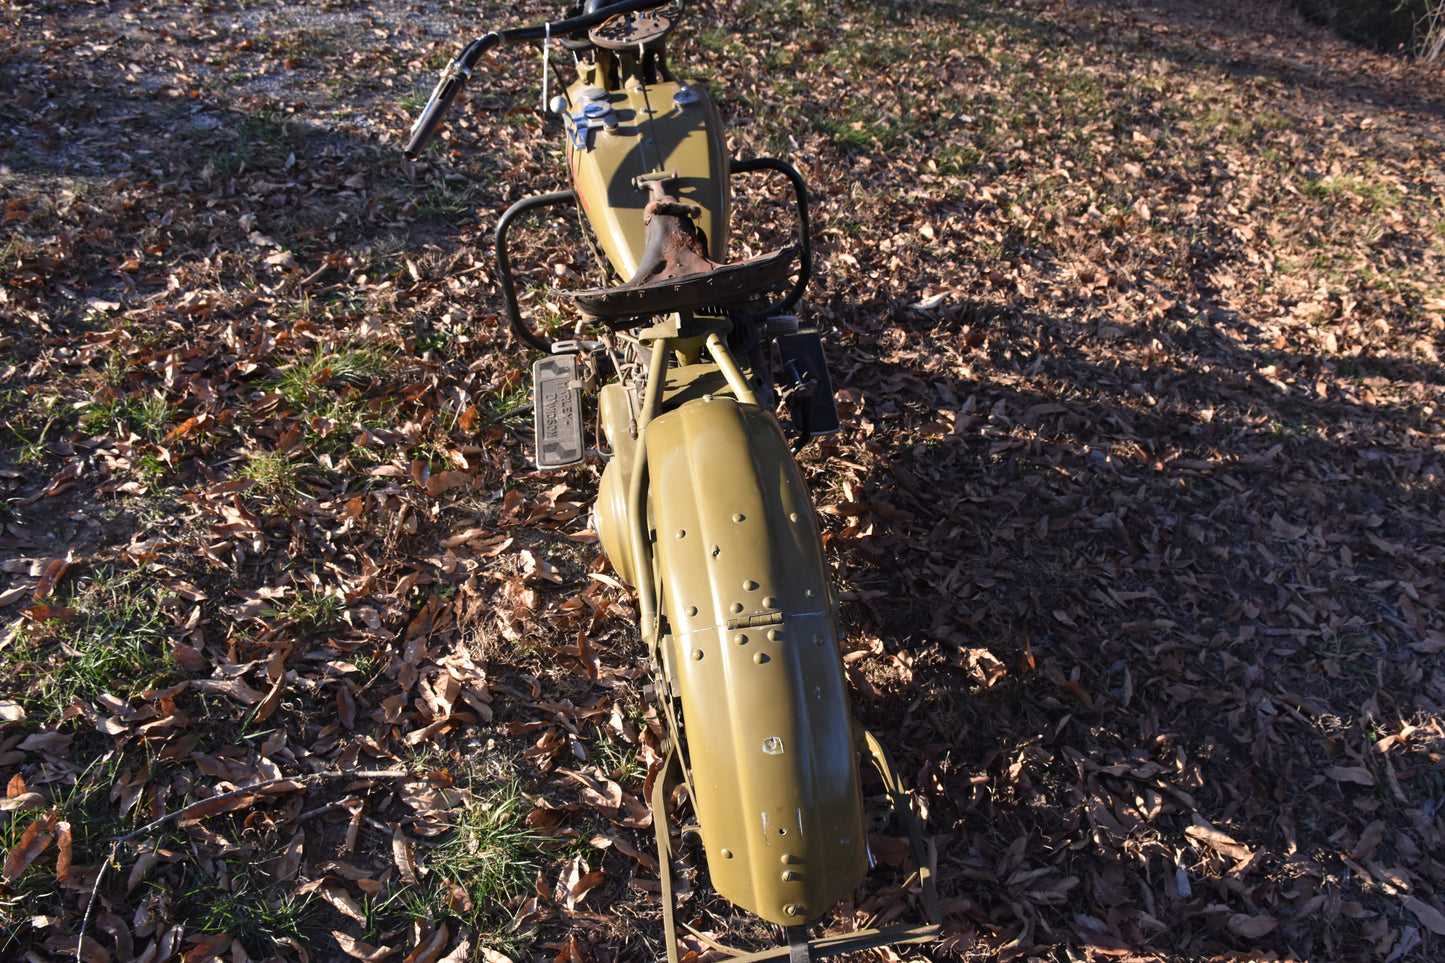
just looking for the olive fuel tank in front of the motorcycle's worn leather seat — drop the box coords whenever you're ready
[566,68,731,281]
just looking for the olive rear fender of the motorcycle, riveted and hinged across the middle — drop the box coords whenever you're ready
[646,396,867,925]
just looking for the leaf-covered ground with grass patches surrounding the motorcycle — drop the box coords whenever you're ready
[0,0,1445,963]
